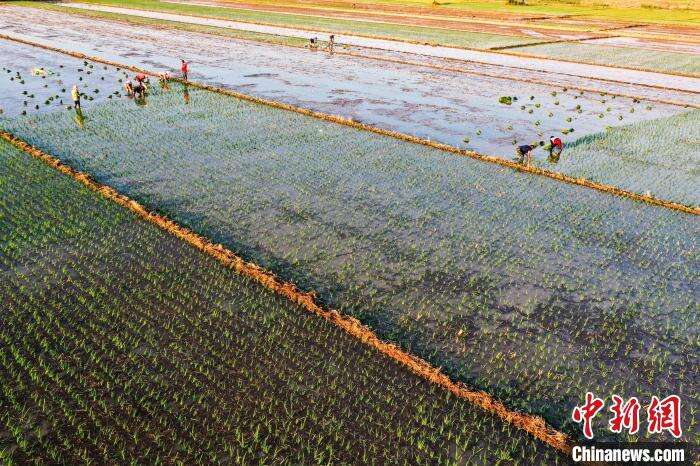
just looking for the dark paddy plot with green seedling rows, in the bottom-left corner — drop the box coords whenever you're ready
[0,140,562,464]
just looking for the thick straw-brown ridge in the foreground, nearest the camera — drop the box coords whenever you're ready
[0,130,572,454]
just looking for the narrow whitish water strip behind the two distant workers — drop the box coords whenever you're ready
[64,3,700,93]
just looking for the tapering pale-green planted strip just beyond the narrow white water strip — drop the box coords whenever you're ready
[58,0,540,49]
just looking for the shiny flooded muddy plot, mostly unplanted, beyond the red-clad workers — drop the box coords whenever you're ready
[0,8,685,158]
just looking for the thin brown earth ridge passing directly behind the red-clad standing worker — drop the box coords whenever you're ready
[0,34,700,215]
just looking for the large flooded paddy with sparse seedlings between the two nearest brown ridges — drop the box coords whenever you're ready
[2,87,700,440]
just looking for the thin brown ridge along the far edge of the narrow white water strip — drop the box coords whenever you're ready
[58,1,700,79]
